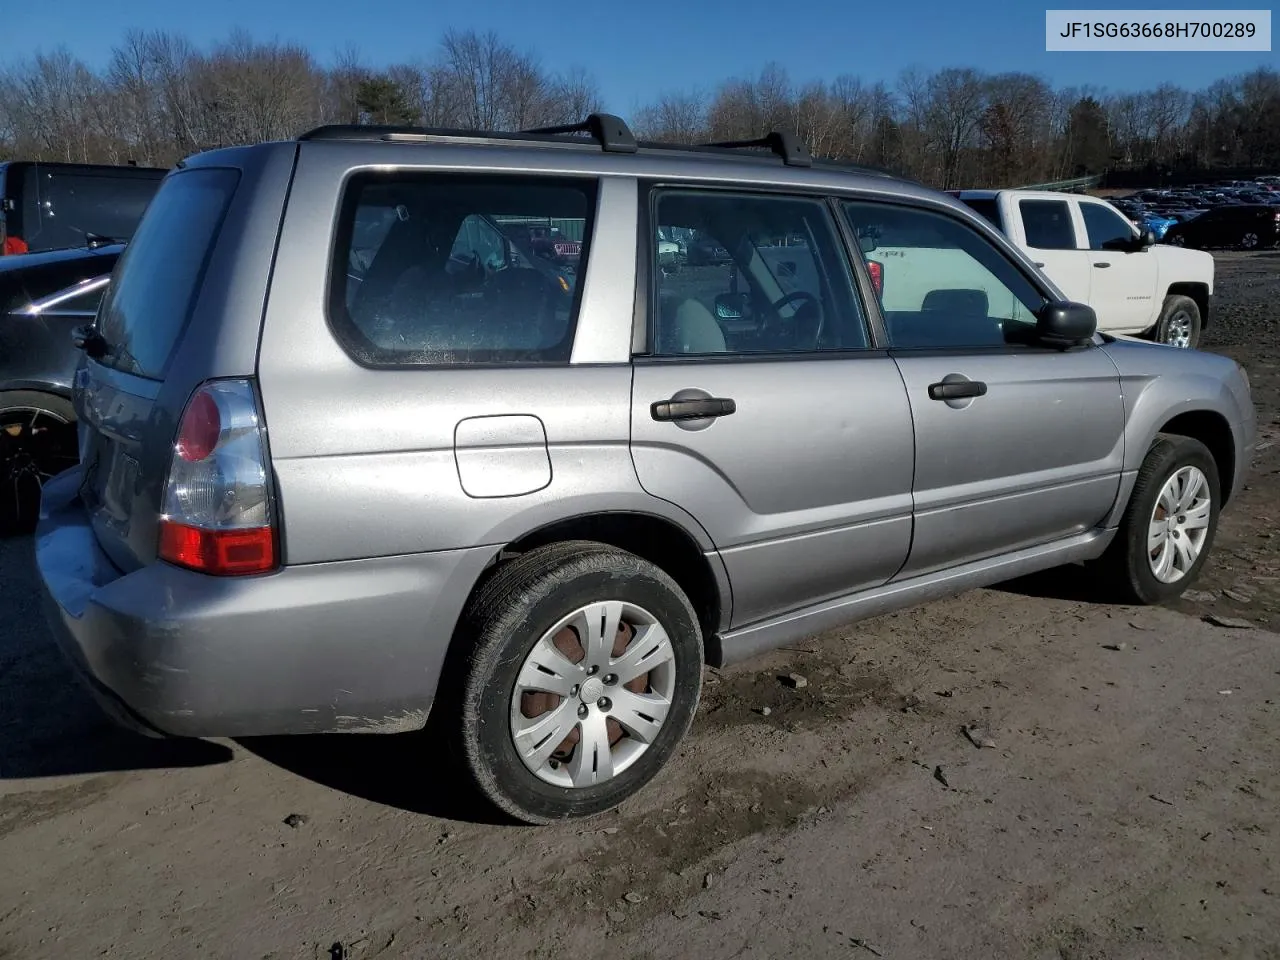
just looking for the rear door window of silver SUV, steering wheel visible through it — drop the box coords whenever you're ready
[650,191,868,356]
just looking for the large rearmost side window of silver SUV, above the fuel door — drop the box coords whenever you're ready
[329,173,595,366]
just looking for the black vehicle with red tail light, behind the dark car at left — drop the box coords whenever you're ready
[0,160,166,255]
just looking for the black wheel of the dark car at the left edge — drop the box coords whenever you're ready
[0,390,79,536]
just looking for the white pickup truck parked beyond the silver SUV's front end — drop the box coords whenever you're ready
[951,189,1213,347]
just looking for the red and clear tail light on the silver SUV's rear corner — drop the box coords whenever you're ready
[159,380,279,576]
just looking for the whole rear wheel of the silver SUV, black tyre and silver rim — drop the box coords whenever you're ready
[458,541,703,823]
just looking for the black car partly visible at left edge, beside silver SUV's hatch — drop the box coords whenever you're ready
[0,243,124,536]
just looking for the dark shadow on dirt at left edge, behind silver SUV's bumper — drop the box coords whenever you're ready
[0,538,233,781]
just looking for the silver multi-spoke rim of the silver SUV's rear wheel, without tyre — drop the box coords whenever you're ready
[511,600,676,787]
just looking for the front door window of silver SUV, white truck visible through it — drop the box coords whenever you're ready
[845,201,1044,349]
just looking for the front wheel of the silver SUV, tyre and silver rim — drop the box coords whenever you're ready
[1096,434,1221,604]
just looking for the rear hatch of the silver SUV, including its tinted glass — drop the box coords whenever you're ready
[76,166,239,571]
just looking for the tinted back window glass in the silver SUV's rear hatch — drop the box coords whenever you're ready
[97,169,239,380]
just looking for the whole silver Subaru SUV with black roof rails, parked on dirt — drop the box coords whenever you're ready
[36,114,1254,823]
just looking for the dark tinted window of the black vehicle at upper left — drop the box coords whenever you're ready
[22,164,160,251]
